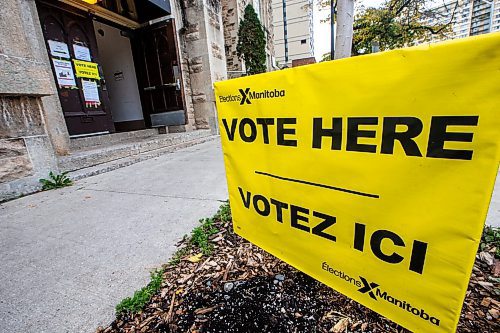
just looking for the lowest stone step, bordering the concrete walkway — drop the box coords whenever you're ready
[68,135,218,180]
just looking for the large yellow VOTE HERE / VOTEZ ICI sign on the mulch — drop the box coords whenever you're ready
[215,33,500,333]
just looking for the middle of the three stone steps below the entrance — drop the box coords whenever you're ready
[59,130,212,171]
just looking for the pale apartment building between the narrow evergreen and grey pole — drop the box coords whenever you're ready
[272,0,314,67]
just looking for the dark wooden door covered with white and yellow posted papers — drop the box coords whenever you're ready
[37,2,115,135]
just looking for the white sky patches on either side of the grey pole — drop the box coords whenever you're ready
[313,0,384,61]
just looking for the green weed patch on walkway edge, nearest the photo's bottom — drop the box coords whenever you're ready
[116,269,164,316]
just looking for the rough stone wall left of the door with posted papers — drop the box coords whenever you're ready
[0,0,59,201]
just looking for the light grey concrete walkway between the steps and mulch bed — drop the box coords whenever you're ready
[0,140,228,333]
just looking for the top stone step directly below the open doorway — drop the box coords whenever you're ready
[70,128,158,151]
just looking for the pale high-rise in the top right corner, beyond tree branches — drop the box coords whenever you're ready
[425,0,500,41]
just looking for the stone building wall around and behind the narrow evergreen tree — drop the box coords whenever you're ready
[222,0,276,78]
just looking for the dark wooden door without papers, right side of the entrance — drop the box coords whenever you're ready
[135,19,186,125]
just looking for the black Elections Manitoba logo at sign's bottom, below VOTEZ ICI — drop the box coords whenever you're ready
[321,262,440,326]
